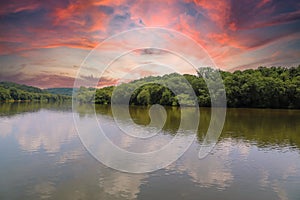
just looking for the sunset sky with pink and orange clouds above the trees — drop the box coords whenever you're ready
[0,0,300,88]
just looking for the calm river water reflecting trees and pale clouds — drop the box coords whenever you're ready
[0,103,300,200]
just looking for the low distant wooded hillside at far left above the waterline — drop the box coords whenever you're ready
[0,82,71,102]
